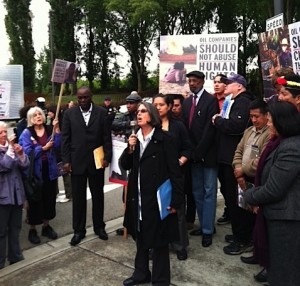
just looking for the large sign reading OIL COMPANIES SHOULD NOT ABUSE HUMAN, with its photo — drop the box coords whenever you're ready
[159,33,238,94]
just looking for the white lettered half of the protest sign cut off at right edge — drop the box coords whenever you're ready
[288,22,300,75]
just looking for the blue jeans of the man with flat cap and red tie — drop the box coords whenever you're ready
[191,163,218,234]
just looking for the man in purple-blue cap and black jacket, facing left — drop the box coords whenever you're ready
[212,74,254,255]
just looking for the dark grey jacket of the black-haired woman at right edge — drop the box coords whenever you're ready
[244,136,300,221]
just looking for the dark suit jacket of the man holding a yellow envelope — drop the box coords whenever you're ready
[61,104,112,175]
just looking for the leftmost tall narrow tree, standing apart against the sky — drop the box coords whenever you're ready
[3,0,36,91]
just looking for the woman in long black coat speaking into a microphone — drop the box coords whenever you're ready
[120,102,183,286]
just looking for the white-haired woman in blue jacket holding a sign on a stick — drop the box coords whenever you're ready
[20,106,60,244]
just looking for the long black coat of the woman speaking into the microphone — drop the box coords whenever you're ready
[120,129,184,248]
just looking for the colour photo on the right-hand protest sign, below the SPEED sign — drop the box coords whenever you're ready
[259,26,293,98]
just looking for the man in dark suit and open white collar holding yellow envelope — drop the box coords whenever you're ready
[62,87,112,246]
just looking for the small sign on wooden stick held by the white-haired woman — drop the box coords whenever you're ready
[51,59,79,83]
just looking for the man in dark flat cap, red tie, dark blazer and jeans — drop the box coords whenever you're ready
[183,71,219,247]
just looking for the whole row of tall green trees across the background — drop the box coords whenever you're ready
[3,0,300,94]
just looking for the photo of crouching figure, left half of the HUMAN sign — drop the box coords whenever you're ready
[159,35,198,94]
